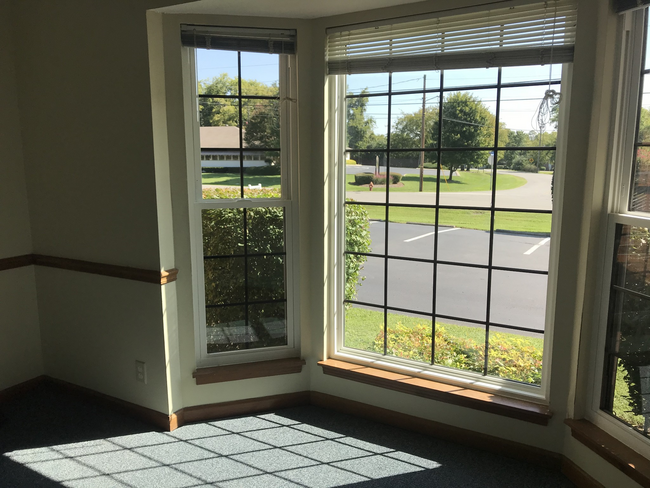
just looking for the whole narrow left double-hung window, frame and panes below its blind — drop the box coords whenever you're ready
[184,37,300,367]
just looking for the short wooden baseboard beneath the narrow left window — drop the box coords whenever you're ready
[175,391,310,427]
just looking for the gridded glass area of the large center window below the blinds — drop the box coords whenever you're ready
[337,65,561,385]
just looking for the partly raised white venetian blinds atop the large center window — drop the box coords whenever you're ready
[327,0,577,75]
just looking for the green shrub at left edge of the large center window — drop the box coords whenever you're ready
[345,199,370,300]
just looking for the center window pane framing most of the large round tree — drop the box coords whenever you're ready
[441,90,497,148]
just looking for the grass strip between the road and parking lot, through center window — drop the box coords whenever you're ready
[365,205,551,234]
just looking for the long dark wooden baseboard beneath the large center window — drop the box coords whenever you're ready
[310,391,562,470]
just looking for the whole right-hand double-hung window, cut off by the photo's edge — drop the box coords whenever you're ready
[591,2,650,450]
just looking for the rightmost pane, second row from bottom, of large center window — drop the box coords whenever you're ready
[490,270,548,331]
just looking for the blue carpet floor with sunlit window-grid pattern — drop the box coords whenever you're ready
[0,384,573,488]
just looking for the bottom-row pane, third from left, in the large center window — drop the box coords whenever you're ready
[434,318,485,373]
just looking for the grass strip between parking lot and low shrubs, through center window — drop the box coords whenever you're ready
[345,307,544,351]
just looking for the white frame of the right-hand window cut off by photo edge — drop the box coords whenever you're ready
[585,6,650,452]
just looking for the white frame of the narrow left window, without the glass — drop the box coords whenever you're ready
[182,47,300,368]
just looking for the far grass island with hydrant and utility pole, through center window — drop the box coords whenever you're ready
[346,171,526,192]
